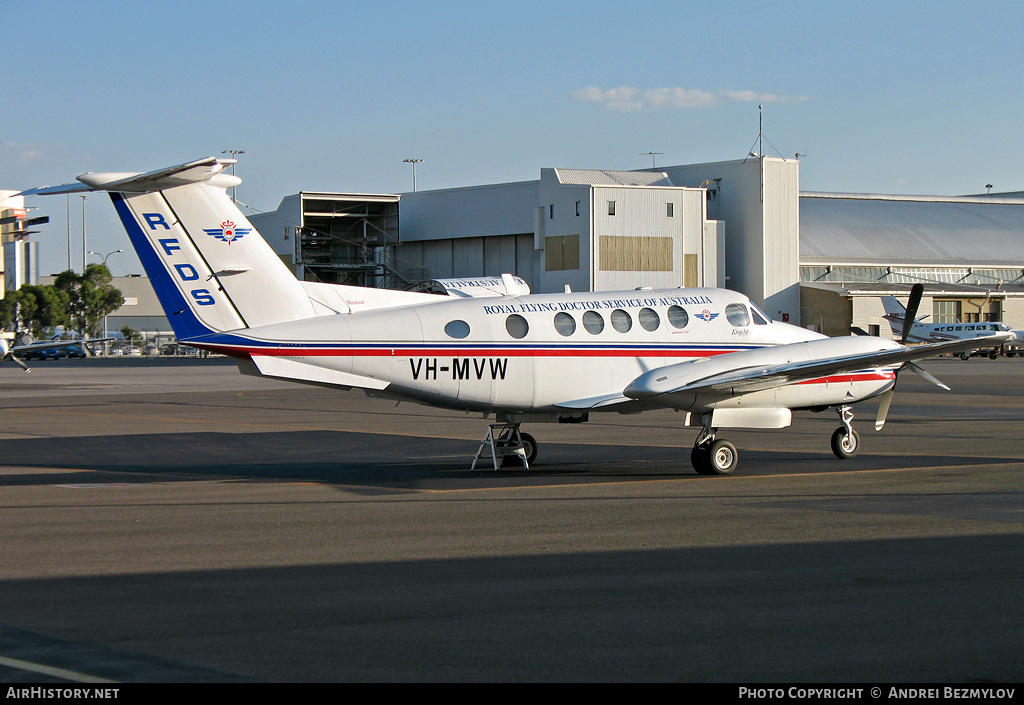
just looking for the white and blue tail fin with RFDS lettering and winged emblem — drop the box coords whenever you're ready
[26,157,315,339]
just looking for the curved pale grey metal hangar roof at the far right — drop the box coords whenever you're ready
[800,193,1024,266]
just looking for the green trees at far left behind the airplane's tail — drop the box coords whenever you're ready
[0,264,125,339]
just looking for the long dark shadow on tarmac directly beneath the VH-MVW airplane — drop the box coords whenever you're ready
[0,430,1008,490]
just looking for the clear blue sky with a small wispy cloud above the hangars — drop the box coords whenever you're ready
[0,0,1024,274]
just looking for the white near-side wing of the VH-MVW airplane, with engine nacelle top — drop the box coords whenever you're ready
[623,333,1016,400]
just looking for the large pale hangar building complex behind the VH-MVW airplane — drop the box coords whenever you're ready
[250,156,1024,336]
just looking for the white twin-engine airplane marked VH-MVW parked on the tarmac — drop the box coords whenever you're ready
[24,157,1011,474]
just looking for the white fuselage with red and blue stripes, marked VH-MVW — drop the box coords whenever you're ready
[196,289,894,415]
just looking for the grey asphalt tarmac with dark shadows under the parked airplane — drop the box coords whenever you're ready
[0,359,1024,683]
